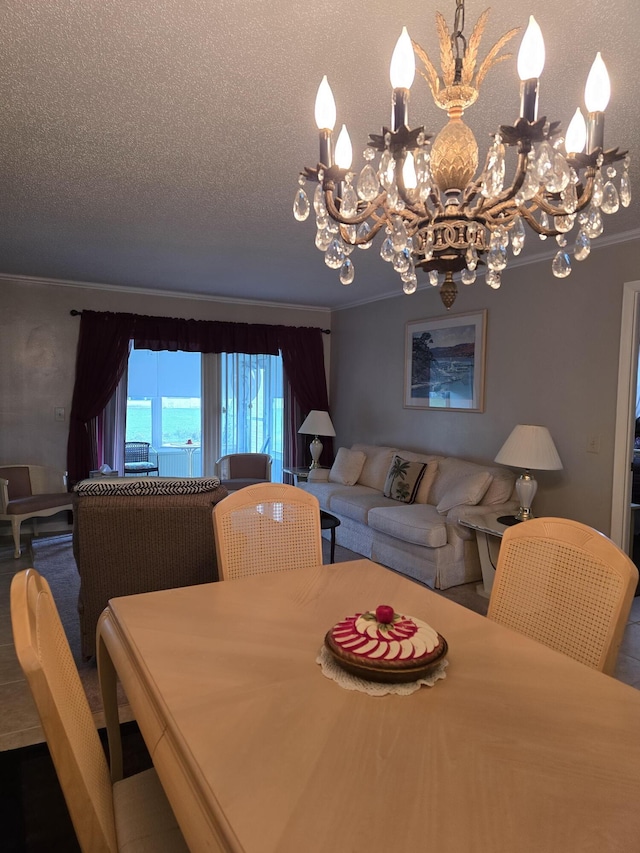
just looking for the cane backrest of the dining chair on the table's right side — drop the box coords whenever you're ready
[487,518,638,675]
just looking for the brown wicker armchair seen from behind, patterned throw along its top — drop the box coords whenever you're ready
[73,477,227,659]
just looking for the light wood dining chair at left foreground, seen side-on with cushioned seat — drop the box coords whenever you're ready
[11,569,188,853]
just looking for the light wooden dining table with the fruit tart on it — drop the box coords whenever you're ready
[98,560,640,853]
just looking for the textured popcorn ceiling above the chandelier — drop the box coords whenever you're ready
[0,0,640,307]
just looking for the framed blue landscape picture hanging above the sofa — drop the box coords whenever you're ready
[404,310,487,412]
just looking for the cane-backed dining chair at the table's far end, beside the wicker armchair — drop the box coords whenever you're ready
[213,483,322,580]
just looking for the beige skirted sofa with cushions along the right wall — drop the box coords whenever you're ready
[300,444,518,589]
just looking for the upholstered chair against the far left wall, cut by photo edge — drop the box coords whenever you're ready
[0,465,72,558]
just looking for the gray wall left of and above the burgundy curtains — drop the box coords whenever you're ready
[0,281,331,470]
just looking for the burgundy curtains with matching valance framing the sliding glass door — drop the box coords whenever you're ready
[67,311,333,484]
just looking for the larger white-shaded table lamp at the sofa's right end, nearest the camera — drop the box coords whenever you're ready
[495,424,562,524]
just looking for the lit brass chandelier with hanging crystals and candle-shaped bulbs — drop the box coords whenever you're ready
[293,0,631,308]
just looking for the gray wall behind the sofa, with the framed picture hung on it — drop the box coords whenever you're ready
[331,240,640,533]
